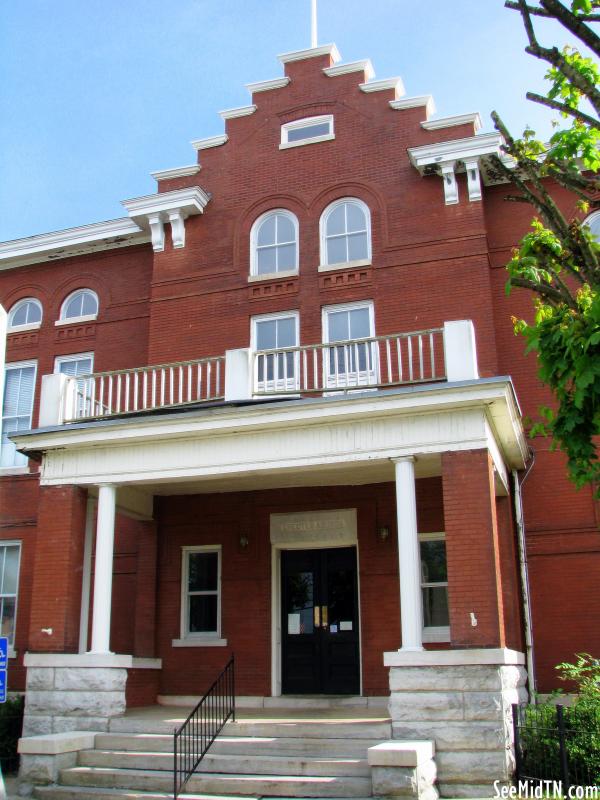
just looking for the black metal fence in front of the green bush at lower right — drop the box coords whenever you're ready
[513,703,600,797]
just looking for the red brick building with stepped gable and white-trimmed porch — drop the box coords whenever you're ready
[0,46,600,800]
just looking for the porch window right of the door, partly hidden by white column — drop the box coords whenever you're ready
[419,533,450,641]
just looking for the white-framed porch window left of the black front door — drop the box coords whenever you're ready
[182,547,221,638]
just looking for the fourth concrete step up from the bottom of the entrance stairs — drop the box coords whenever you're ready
[96,733,378,758]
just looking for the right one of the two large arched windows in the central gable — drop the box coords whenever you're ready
[321,197,371,266]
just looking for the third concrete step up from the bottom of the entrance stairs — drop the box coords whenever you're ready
[78,750,371,777]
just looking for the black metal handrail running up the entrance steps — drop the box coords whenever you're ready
[173,655,235,800]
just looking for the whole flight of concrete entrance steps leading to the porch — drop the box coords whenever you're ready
[34,707,391,800]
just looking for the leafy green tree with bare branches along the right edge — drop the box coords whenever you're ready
[492,0,600,496]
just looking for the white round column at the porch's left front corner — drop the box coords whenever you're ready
[90,485,117,653]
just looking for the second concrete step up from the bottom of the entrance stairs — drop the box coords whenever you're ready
[59,767,372,798]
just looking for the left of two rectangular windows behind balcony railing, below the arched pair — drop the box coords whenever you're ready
[252,312,299,392]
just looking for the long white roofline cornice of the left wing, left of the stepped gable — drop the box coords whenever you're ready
[0,217,149,269]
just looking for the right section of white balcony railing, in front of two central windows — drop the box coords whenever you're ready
[253,328,446,395]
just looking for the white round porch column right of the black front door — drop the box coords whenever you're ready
[393,457,423,651]
